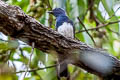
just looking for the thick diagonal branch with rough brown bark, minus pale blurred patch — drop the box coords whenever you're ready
[0,0,120,77]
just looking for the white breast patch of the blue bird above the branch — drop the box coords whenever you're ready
[57,22,74,38]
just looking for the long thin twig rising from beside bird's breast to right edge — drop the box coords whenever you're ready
[76,20,120,34]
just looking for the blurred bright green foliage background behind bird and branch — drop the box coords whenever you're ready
[0,0,120,80]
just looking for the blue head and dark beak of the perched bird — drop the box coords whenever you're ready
[48,8,66,17]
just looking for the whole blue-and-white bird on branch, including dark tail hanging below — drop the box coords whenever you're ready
[48,8,75,80]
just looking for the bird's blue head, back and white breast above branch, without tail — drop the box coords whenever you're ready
[49,8,75,38]
